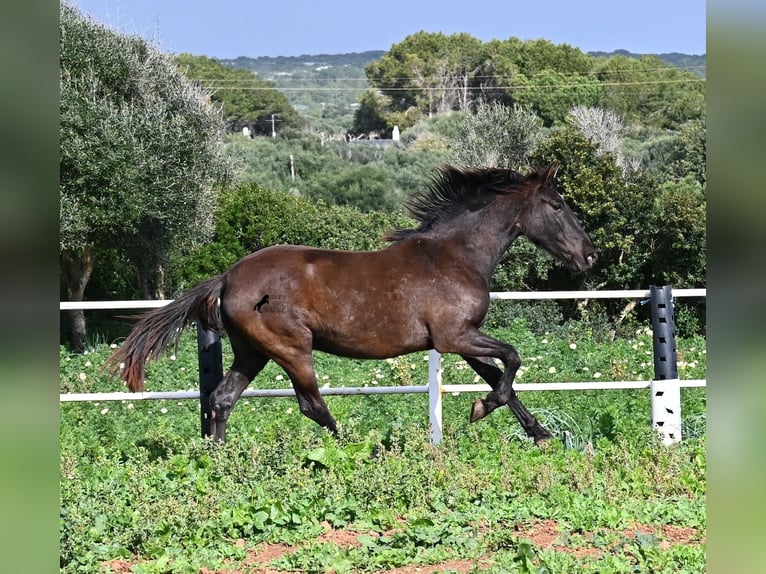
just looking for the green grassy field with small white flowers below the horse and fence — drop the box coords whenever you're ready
[60,323,706,573]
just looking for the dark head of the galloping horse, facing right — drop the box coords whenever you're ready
[516,162,596,272]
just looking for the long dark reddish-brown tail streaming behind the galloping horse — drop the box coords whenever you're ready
[106,275,224,392]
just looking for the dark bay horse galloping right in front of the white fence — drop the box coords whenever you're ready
[109,163,596,443]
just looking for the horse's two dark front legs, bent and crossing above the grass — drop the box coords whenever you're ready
[463,355,552,444]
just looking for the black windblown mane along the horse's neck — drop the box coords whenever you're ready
[386,165,525,241]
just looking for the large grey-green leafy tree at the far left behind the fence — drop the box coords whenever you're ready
[59,3,230,348]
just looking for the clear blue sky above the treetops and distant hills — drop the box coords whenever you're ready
[69,0,707,58]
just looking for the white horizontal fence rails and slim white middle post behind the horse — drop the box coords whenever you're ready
[59,289,707,443]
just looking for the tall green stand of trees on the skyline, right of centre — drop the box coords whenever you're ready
[366,32,705,135]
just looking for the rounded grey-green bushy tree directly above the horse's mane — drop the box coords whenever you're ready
[451,103,542,170]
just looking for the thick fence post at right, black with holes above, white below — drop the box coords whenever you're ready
[649,285,681,445]
